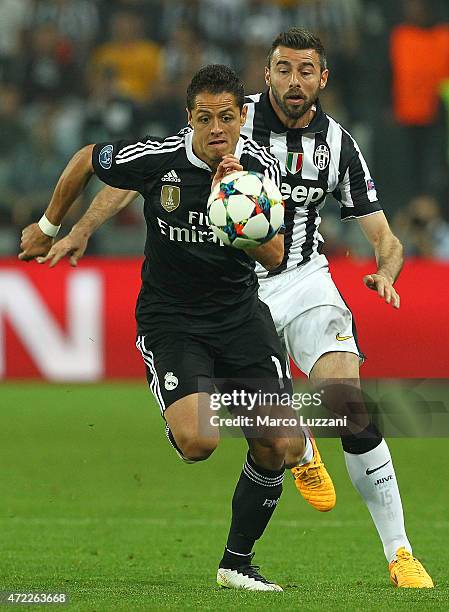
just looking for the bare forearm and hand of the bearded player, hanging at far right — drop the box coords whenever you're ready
[358,211,404,308]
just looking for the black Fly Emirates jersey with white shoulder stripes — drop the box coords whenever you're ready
[92,128,281,333]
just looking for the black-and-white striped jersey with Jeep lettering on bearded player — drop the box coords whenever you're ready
[242,92,381,278]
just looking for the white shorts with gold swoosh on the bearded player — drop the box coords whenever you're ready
[259,262,364,376]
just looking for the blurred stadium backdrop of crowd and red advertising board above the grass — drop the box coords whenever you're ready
[0,0,449,381]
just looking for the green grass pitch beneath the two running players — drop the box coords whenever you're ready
[0,382,449,612]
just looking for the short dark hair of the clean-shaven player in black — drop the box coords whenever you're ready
[187,64,245,111]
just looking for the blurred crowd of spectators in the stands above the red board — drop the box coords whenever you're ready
[0,0,449,260]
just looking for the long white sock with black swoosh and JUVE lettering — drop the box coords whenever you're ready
[345,440,412,562]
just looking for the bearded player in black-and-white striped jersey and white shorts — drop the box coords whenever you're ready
[242,28,433,588]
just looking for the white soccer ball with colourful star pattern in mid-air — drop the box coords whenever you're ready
[207,170,284,249]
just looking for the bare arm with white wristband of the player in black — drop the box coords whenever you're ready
[19,145,94,261]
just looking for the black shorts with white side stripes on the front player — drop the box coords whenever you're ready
[136,300,292,414]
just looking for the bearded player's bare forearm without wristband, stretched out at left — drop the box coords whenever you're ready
[37,185,139,268]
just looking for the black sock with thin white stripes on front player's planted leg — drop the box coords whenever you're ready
[220,453,285,568]
